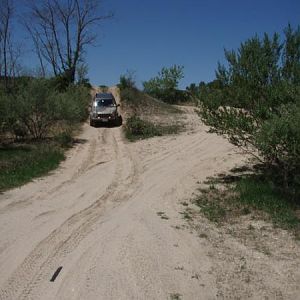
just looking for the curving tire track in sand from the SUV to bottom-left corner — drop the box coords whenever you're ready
[0,130,137,300]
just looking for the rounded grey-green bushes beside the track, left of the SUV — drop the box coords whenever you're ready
[0,79,90,139]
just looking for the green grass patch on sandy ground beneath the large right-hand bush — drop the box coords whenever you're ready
[193,175,300,236]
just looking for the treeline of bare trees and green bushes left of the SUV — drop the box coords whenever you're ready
[0,0,111,142]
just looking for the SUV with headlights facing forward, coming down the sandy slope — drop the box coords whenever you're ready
[90,93,121,126]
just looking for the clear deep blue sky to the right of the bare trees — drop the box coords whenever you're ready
[18,0,300,88]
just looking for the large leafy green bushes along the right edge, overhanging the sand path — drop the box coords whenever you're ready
[192,25,300,200]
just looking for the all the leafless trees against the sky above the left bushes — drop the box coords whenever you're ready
[0,0,112,91]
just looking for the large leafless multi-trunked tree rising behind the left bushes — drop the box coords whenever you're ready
[26,0,112,83]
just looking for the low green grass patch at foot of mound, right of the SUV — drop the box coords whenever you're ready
[125,115,180,141]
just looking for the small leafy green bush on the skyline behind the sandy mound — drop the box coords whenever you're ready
[143,65,186,103]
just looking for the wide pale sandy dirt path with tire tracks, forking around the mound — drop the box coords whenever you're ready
[0,95,295,300]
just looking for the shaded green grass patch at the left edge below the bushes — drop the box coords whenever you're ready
[0,142,64,191]
